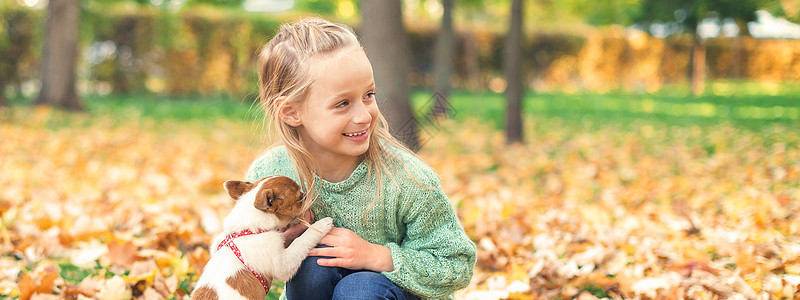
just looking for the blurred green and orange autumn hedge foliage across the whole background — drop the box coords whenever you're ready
[0,0,800,99]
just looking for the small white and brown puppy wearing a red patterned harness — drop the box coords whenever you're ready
[192,176,333,300]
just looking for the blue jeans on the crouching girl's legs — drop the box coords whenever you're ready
[286,247,419,300]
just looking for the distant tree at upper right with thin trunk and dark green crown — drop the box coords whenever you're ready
[639,0,761,95]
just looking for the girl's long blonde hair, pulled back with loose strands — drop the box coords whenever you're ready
[258,18,419,214]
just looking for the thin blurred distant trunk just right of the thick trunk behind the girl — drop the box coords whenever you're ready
[431,0,455,117]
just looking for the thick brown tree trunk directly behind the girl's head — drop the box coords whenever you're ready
[361,0,420,151]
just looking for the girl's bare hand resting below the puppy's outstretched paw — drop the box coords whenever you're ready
[308,227,394,272]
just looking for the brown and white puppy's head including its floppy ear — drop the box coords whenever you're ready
[223,176,305,222]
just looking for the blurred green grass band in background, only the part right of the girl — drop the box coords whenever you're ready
[412,86,800,129]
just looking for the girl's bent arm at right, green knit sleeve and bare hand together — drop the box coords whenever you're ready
[309,173,476,298]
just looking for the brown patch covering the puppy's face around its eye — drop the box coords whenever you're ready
[254,176,304,222]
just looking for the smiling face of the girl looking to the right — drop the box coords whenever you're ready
[287,47,379,168]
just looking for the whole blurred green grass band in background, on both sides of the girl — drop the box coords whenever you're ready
[7,81,800,129]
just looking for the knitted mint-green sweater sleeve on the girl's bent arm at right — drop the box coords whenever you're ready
[383,177,476,298]
